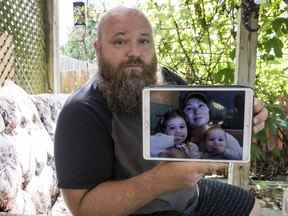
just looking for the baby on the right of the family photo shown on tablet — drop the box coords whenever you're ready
[203,126,242,160]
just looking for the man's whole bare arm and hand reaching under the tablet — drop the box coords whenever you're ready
[62,162,224,216]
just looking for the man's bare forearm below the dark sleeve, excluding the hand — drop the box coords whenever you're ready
[62,167,161,216]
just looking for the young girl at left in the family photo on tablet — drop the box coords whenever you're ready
[151,110,201,159]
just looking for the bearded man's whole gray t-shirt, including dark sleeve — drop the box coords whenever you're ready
[55,70,197,214]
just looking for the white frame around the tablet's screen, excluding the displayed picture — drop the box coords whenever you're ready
[142,86,254,163]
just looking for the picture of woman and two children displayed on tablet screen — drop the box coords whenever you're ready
[149,89,251,161]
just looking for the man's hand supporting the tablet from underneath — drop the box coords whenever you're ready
[151,162,228,192]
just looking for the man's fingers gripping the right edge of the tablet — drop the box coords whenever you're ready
[253,98,268,134]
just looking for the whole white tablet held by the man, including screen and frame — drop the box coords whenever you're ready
[143,86,253,163]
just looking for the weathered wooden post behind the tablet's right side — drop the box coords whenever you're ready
[228,0,258,188]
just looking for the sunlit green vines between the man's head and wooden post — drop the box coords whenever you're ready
[145,0,238,84]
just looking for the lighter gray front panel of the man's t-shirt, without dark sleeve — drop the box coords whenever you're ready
[112,114,197,214]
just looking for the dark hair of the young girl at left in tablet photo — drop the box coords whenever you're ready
[153,109,191,142]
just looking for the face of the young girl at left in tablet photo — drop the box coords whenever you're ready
[165,117,187,145]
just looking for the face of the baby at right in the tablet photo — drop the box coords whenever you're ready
[206,128,226,153]
